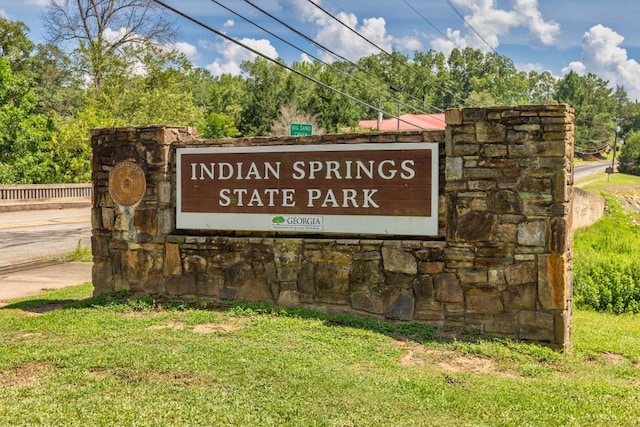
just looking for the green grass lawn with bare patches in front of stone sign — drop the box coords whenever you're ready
[0,284,640,426]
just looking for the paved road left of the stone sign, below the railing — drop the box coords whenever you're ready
[0,208,91,270]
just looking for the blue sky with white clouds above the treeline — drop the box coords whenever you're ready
[0,0,640,100]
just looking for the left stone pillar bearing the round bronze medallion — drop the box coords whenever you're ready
[91,126,195,295]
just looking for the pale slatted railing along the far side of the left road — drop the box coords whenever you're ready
[0,184,93,202]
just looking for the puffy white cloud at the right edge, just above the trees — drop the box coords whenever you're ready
[562,24,640,101]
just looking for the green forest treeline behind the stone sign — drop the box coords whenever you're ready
[0,0,640,184]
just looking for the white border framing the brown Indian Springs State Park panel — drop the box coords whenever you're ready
[176,142,440,236]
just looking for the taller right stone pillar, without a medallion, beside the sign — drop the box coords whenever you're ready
[445,105,573,346]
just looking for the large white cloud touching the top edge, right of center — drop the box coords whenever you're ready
[431,0,560,54]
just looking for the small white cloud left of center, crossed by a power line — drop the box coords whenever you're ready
[206,38,278,76]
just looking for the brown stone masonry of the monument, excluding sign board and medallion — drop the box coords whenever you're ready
[92,105,573,348]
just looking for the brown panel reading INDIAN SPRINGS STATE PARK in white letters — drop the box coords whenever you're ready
[178,143,438,237]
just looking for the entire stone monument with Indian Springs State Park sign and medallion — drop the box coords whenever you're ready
[92,105,574,349]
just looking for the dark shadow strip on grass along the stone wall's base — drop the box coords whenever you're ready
[0,292,480,344]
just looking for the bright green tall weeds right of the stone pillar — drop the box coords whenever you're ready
[573,196,640,314]
